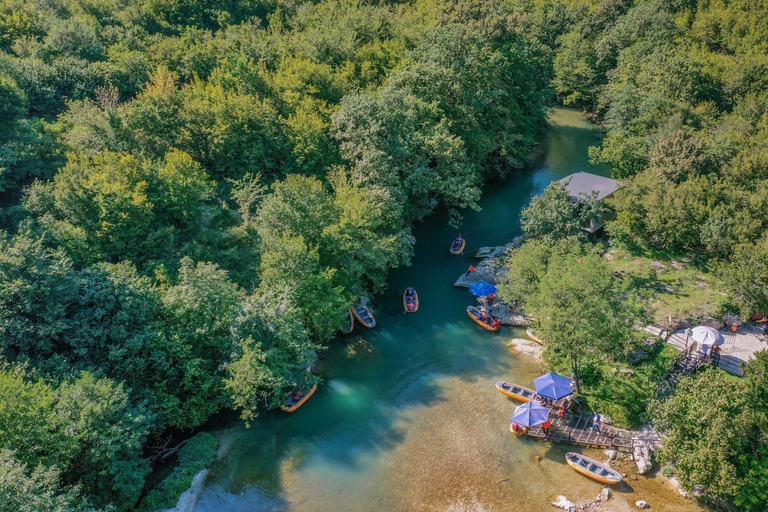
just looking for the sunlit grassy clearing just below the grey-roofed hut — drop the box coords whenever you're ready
[606,249,722,325]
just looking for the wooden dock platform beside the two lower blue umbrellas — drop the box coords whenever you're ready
[528,409,633,451]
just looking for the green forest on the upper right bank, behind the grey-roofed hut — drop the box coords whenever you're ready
[572,1,768,288]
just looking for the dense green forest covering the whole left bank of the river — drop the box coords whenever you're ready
[0,0,553,512]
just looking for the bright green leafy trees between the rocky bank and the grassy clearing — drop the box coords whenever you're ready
[499,239,652,390]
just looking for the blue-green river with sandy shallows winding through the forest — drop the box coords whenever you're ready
[194,108,699,512]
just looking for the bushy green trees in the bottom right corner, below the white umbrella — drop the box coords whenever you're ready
[653,353,768,511]
